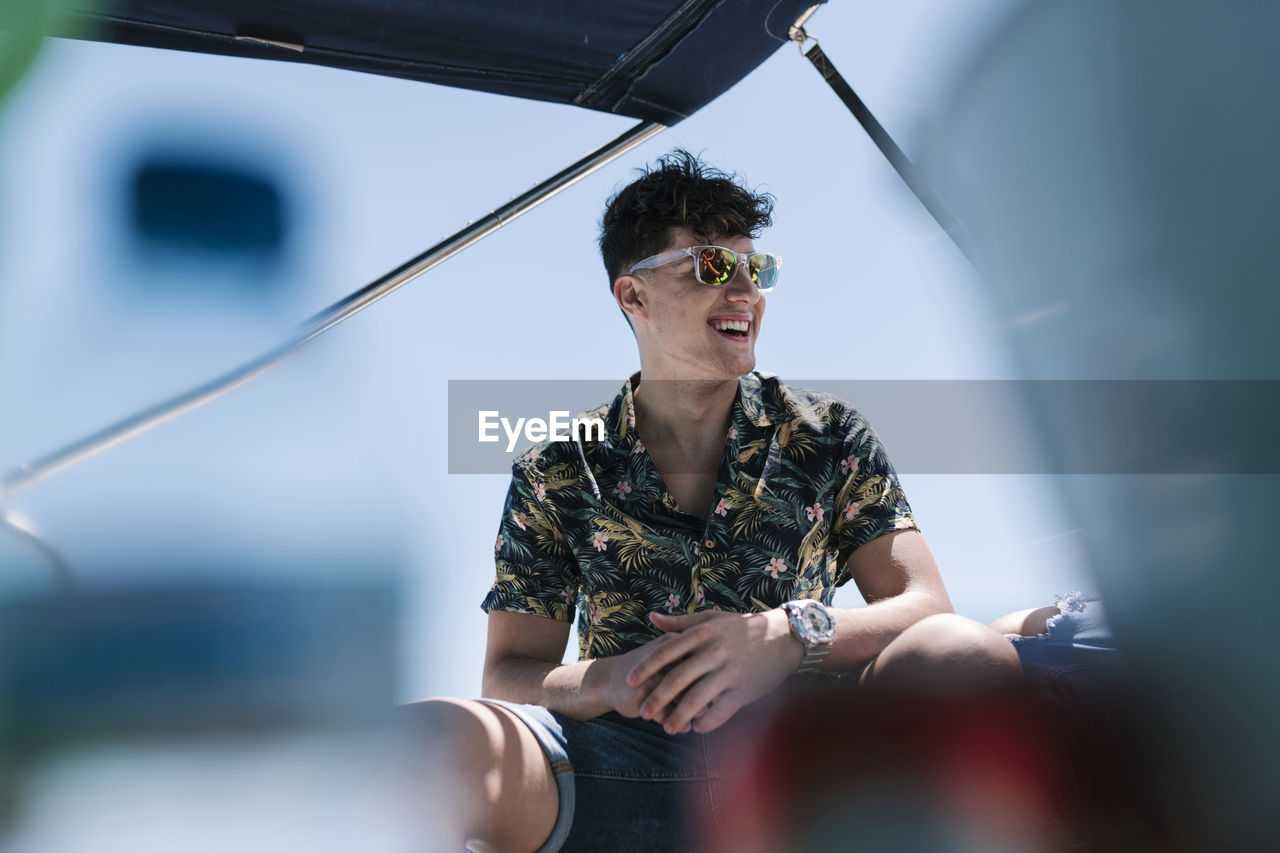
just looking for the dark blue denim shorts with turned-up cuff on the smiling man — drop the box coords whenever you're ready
[480,699,763,853]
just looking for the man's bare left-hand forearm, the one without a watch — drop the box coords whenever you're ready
[483,657,612,720]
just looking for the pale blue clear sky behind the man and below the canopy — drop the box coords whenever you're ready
[0,0,1093,698]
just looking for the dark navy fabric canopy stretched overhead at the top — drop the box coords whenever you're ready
[55,0,824,124]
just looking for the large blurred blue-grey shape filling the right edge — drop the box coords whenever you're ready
[929,0,1280,849]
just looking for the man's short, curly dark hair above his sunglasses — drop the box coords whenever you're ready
[600,149,773,291]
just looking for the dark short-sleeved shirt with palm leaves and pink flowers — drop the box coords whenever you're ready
[481,373,916,658]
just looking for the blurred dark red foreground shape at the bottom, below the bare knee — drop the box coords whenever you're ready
[707,680,1175,853]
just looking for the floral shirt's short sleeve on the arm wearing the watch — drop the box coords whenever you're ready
[832,411,919,587]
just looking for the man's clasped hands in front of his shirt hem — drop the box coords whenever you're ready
[599,610,803,734]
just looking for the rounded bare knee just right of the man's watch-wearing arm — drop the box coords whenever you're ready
[864,613,1021,688]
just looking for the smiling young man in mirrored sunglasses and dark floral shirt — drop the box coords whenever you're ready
[415,151,1019,850]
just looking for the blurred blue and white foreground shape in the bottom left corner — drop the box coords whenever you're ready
[0,573,440,853]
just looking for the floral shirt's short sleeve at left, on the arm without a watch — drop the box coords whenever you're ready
[480,466,580,622]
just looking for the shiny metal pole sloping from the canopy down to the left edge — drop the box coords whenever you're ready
[0,122,666,497]
